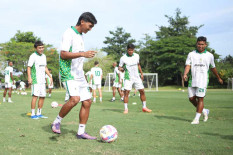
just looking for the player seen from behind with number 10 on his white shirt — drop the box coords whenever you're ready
[89,61,103,103]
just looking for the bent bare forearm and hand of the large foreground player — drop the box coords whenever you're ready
[60,51,97,59]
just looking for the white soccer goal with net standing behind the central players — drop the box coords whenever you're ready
[104,73,158,91]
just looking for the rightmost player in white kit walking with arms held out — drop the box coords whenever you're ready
[183,36,223,124]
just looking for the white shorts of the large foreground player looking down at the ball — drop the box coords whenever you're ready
[63,80,91,101]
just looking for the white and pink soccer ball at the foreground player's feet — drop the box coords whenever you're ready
[100,125,118,143]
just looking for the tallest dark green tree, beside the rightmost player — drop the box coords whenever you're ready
[154,9,203,86]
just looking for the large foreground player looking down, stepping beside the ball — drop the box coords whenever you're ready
[52,12,97,139]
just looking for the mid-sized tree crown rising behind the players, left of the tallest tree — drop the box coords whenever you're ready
[102,27,136,60]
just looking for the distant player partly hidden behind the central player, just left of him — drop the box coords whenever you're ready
[111,62,124,102]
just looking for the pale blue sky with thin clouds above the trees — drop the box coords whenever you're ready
[0,0,233,58]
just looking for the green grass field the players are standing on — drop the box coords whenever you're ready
[0,90,233,155]
